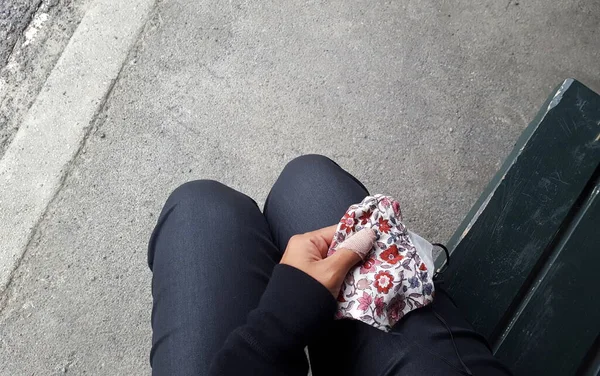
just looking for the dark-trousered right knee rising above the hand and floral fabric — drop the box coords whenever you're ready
[264,155,369,250]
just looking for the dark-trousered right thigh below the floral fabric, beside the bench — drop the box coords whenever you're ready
[309,290,510,376]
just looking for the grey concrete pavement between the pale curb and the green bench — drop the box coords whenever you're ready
[0,0,600,375]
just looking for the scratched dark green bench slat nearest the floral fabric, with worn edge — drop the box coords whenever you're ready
[444,80,600,343]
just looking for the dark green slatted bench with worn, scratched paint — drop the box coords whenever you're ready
[444,79,600,376]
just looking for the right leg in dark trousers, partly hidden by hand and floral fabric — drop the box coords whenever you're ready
[265,155,510,375]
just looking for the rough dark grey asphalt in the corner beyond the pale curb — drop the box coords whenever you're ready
[0,0,93,157]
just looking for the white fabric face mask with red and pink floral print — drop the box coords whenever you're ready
[328,195,434,332]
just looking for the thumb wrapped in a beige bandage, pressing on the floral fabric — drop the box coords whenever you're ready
[324,228,376,272]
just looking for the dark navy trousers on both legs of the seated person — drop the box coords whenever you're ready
[148,155,508,376]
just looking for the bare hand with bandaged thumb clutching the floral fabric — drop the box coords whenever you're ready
[281,225,374,297]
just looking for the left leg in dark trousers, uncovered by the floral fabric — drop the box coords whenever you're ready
[148,181,307,375]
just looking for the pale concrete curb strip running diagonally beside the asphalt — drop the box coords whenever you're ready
[0,0,155,293]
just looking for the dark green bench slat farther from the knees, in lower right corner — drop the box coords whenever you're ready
[495,178,600,375]
